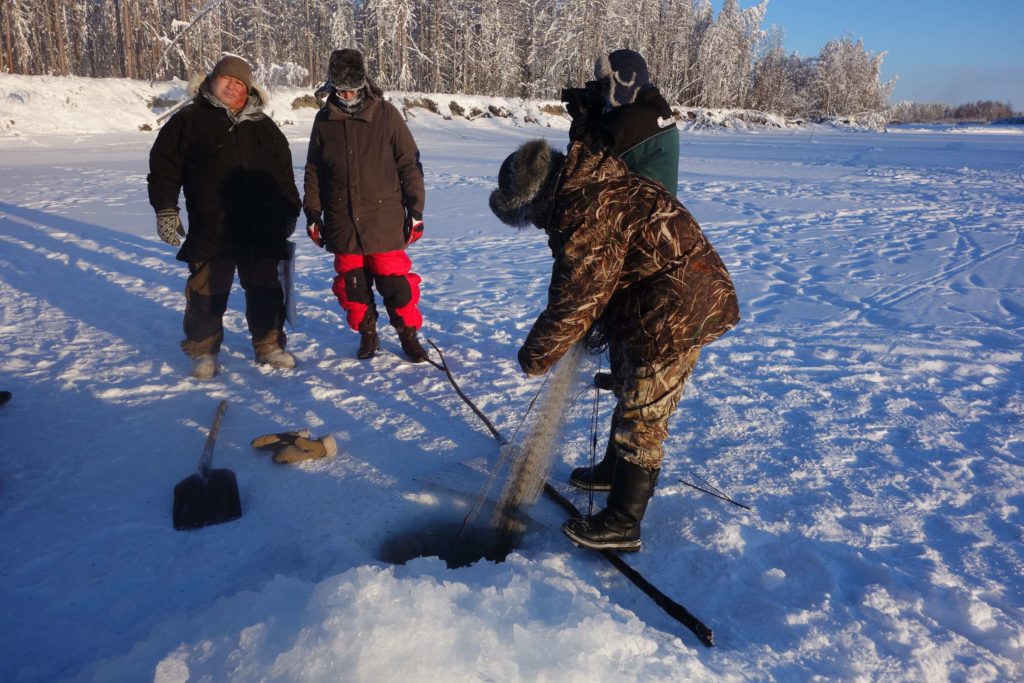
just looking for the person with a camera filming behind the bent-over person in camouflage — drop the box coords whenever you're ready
[562,50,679,195]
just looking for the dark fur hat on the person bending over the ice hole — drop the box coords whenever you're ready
[489,139,565,227]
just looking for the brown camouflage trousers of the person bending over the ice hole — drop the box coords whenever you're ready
[609,347,700,470]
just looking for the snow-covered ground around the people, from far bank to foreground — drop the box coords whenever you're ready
[0,76,1024,682]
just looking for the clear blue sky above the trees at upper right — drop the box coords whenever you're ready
[712,0,1024,111]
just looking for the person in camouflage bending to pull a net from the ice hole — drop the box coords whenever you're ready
[490,140,739,550]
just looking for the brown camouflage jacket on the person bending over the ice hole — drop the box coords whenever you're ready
[519,142,739,375]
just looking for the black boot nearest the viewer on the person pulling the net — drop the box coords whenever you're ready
[562,459,658,552]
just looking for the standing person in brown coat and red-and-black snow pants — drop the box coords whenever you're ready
[302,49,427,362]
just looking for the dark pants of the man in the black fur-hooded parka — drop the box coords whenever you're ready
[181,258,287,358]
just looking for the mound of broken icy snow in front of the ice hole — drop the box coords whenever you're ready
[81,555,710,683]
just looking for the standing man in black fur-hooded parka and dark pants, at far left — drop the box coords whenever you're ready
[146,56,301,380]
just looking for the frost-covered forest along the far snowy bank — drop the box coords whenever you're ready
[0,0,1012,121]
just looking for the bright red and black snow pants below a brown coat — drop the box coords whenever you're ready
[331,250,423,330]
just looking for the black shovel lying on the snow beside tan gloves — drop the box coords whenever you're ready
[174,400,242,531]
